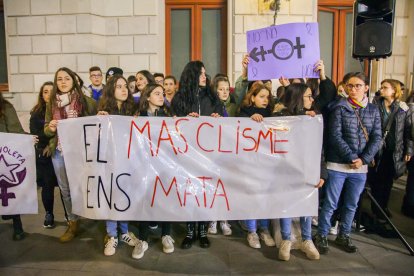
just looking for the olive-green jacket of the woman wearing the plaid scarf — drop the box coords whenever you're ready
[45,94,97,155]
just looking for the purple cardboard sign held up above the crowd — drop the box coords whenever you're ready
[247,23,320,80]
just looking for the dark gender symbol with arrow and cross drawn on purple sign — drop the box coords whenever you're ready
[249,37,305,62]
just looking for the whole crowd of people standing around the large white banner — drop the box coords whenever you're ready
[0,55,414,261]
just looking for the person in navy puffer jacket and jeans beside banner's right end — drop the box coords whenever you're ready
[313,72,382,254]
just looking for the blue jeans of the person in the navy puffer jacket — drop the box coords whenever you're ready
[318,170,367,236]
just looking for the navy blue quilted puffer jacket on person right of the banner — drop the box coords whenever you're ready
[326,98,382,164]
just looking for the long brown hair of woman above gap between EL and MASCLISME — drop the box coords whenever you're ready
[98,74,136,116]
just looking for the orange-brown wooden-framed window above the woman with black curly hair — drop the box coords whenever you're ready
[165,0,227,78]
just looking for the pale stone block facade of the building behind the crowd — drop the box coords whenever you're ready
[4,0,414,111]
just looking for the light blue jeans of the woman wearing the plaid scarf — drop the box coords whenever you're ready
[52,150,79,220]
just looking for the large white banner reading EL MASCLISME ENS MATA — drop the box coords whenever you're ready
[58,116,323,221]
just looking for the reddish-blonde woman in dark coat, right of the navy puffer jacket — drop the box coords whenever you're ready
[368,79,413,222]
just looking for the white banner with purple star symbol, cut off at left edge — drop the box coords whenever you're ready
[0,132,38,215]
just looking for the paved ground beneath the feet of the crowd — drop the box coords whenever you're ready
[0,113,414,276]
